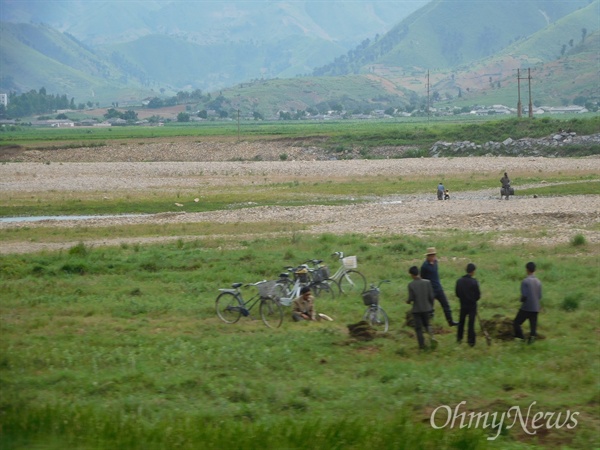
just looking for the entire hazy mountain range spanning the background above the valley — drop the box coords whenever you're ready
[0,0,600,115]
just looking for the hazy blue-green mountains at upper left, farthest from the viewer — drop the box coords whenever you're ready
[0,0,430,101]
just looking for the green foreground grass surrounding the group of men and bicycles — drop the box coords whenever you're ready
[0,231,600,449]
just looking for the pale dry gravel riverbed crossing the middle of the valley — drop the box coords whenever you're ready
[0,150,600,253]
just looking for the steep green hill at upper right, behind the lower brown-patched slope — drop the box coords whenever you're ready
[313,0,599,76]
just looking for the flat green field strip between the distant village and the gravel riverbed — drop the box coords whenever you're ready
[0,114,600,150]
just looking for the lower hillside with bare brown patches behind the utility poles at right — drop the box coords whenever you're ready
[210,0,600,115]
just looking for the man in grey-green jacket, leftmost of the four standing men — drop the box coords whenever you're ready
[406,266,437,350]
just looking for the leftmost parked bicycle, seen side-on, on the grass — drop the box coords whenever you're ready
[215,281,283,328]
